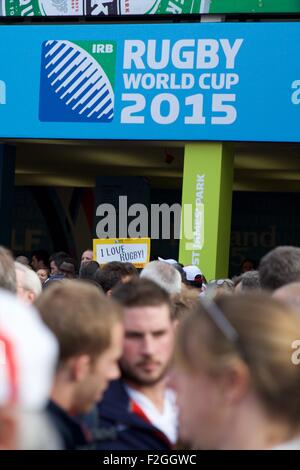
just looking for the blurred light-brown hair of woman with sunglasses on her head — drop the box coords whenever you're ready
[176,294,300,426]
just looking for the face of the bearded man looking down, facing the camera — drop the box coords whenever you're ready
[120,304,175,385]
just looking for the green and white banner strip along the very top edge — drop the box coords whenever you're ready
[0,0,300,17]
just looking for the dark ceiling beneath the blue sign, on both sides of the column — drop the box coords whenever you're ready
[4,140,300,191]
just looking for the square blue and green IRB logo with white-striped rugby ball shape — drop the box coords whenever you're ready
[39,40,116,123]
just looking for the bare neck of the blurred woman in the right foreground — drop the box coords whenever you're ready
[218,398,300,450]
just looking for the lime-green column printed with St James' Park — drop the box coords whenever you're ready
[179,142,233,280]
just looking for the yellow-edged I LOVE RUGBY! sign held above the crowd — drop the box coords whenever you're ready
[93,238,150,268]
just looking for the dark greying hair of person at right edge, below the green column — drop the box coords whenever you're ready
[259,246,300,291]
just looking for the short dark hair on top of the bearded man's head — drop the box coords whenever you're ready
[112,278,171,311]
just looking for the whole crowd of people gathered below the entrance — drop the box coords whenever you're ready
[0,246,300,451]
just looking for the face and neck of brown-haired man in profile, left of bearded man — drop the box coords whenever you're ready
[73,323,124,414]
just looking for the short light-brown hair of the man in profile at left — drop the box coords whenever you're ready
[35,280,120,363]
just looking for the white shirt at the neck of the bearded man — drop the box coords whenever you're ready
[125,385,178,444]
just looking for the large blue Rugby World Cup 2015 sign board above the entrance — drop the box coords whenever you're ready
[0,23,300,142]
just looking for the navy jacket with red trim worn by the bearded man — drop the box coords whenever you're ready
[85,380,172,450]
